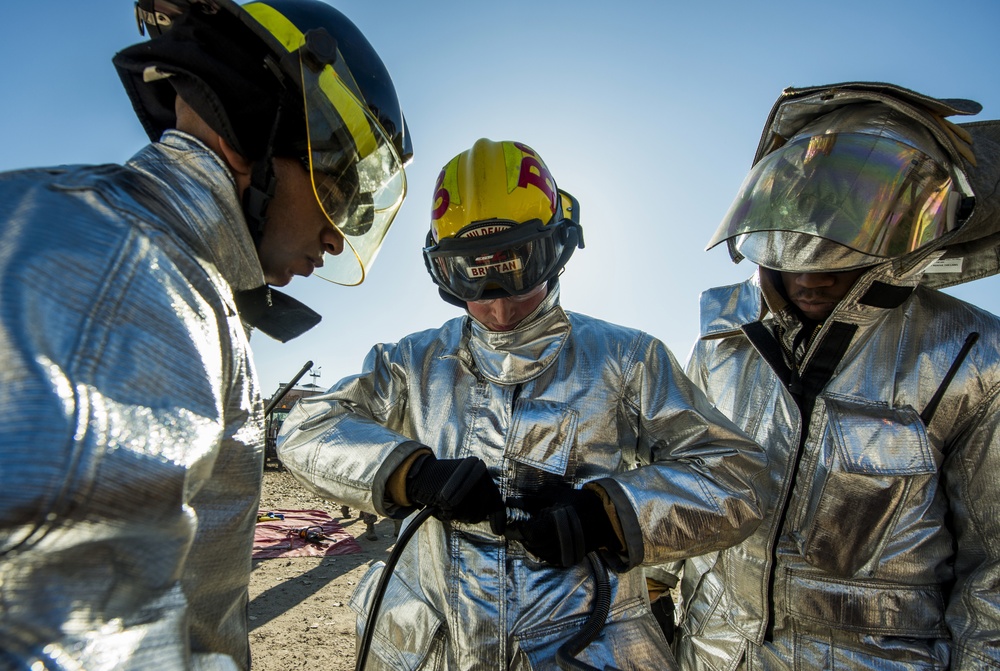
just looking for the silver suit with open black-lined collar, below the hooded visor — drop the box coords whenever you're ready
[677,264,1000,671]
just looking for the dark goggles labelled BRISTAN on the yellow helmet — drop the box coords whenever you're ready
[424,220,575,302]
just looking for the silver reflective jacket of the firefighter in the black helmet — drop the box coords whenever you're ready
[0,132,263,671]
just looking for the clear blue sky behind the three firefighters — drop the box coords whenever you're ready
[0,0,1000,396]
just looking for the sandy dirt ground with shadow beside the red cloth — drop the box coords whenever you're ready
[250,465,395,671]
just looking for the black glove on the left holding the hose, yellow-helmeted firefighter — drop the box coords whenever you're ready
[406,454,504,523]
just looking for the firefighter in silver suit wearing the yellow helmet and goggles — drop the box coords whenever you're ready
[278,139,763,671]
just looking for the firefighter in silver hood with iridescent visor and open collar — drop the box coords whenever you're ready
[676,82,1000,671]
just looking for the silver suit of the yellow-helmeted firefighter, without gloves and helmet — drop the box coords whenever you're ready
[278,287,763,671]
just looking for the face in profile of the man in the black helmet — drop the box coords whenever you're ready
[257,158,344,287]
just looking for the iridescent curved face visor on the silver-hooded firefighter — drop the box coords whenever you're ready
[708,133,961,258]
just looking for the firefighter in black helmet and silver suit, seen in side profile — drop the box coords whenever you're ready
[0,0,409,671]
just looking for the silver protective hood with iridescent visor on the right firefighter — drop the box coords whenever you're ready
[709,83,1000,287]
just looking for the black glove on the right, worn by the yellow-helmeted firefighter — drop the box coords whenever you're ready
[505,487,621,567]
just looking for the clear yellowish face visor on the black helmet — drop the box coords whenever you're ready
[301,58,406,286]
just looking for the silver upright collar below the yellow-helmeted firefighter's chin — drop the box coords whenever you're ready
[467,284,572,384]
